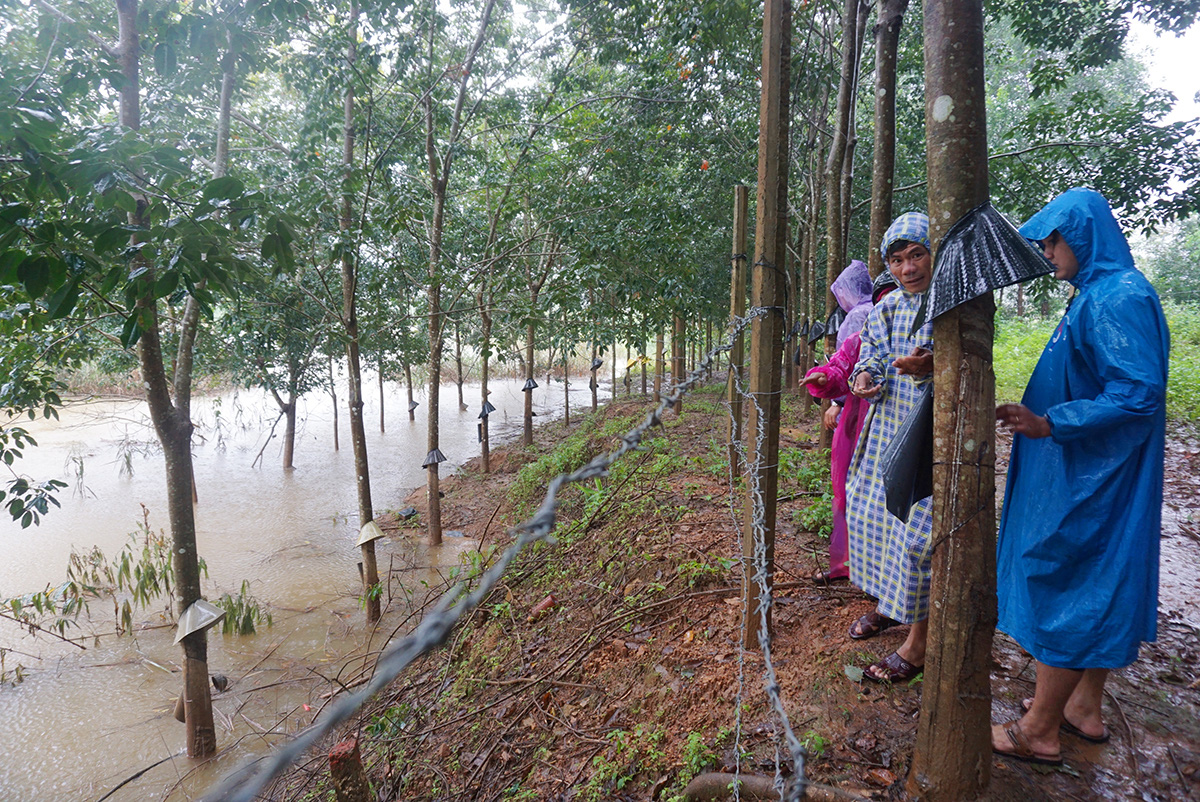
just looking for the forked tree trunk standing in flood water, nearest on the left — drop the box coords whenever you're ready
[116,0,217,758]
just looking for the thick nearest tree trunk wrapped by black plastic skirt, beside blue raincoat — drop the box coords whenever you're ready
[908,0,996,802]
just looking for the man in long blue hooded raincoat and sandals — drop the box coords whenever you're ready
[992,188,1170,765]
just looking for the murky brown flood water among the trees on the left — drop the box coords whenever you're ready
[0,377,610,801]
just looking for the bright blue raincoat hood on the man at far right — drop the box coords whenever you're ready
[1020,187,1136,289]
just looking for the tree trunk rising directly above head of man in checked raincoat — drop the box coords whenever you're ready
[866,0,908,279]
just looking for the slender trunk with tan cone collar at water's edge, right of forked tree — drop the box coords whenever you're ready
[338,2,379,621]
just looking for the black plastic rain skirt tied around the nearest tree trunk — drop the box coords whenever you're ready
[913,203,1054,331]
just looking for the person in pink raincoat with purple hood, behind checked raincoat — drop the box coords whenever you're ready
[804,259,895,585]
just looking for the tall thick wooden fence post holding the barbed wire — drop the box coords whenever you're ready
[742,0,792,648]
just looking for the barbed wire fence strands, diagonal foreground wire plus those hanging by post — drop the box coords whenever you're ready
[204,307,835,802]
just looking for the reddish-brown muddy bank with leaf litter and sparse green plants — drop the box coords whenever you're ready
[275,388,1200,802]
